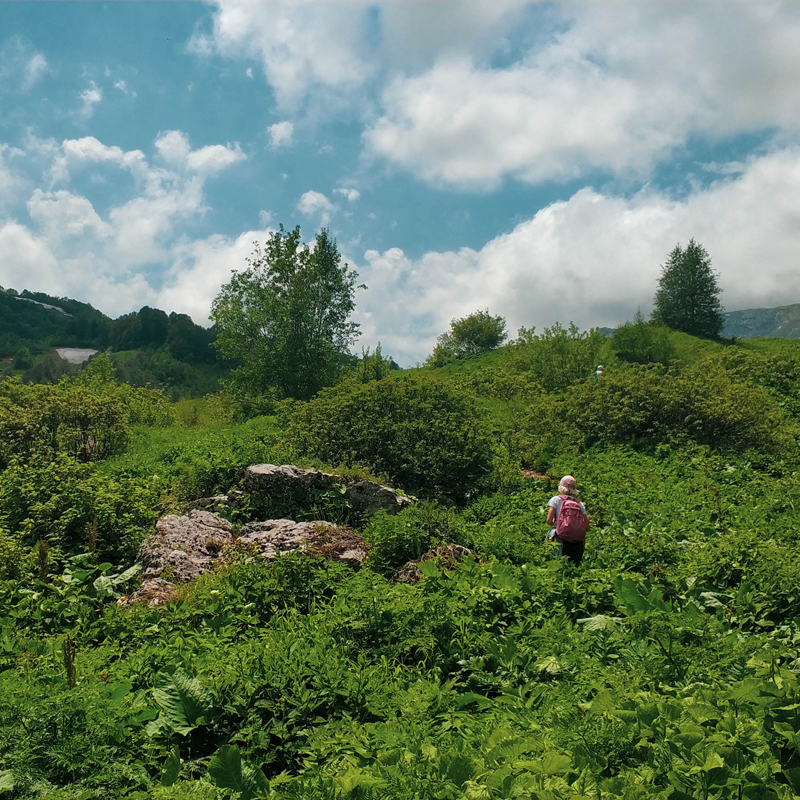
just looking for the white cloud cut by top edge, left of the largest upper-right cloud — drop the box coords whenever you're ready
[189,0,525,108]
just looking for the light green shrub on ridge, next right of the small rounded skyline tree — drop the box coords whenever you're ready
[511,323,606,392]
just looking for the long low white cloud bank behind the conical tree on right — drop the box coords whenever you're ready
[358,148,800,364]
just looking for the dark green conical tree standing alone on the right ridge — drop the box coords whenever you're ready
[653,239,725,338]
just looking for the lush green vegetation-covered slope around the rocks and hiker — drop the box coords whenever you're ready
[0,331,800,800]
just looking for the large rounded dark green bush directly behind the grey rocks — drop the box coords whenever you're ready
[286,376,491,501]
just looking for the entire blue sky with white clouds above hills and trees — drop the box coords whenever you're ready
[0,0,800,366]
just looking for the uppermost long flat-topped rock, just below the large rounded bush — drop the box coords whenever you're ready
[242,464,411,516]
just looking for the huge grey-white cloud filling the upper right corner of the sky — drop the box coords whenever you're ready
[364,3,800,189]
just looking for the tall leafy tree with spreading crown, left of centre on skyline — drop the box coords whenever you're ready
[211,225,359,400]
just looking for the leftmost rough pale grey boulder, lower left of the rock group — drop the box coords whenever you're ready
[137,510,234,582]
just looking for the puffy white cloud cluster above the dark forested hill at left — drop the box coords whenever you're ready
[0,131,244,322]
